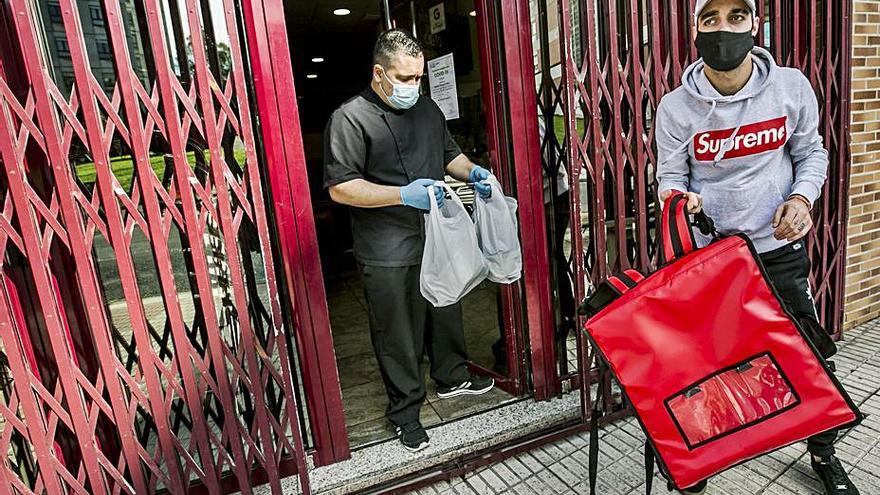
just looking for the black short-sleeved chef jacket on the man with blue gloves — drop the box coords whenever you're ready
[324,88,461,267]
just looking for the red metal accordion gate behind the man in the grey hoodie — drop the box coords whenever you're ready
[532,0,851,400]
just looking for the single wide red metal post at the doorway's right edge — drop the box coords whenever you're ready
[500,0,561,400]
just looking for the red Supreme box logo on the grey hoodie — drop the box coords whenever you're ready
[694,117,788,162]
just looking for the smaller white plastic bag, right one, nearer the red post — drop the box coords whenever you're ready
[474,175,522,284]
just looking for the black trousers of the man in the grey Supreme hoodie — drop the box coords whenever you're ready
[760,241,837,457]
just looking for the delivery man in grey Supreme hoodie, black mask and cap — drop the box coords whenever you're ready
[656,0,859,495]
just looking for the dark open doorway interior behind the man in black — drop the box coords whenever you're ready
[285,0,523,449]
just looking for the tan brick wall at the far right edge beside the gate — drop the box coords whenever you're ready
[844,0,880,328]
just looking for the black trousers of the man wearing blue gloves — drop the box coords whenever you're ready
[361,265,470,426]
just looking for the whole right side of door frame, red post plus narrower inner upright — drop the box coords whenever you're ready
[475,0,561,400]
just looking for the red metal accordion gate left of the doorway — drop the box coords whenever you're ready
[0,0,306,494]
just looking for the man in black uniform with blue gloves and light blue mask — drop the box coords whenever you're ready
[324,29,502,452]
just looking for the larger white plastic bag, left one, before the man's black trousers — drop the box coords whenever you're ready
[419,181,489,308]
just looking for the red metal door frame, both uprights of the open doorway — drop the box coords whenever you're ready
[262,0,560,466]
